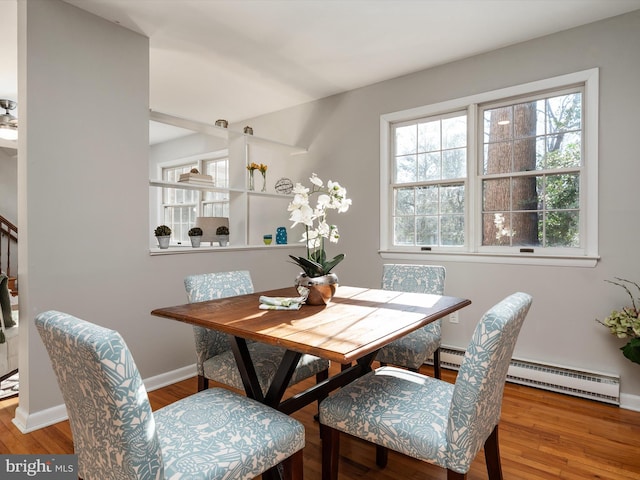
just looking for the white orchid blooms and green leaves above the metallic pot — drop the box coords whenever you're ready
[288,173,351,277]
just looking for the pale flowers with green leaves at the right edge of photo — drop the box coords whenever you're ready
[598,277,640,364]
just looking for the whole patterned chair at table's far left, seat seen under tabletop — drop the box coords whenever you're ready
[184,270,329,393]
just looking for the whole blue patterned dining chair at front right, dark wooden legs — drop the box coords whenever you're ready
[320,292,532,480]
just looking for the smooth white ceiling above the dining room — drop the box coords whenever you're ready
[0,0,640,144]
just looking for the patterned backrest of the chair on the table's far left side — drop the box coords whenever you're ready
[184,270,253,375]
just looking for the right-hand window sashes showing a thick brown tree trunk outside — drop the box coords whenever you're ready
[480,88,583,248]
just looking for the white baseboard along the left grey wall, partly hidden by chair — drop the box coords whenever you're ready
[12,364,197,433]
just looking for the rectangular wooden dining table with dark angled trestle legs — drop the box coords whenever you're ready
[151,285,471,414]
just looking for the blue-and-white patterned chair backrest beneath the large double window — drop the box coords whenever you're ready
[382,263,446,295]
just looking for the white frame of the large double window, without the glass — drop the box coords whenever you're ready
[379,68,599,267]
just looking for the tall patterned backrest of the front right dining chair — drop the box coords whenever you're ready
[447,292,532,472]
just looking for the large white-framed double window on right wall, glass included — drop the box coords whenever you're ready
[381,70,598,264]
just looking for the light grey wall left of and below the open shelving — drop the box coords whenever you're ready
[15,0,304,430]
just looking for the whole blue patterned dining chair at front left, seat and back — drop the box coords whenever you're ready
[35,311,305,480]
